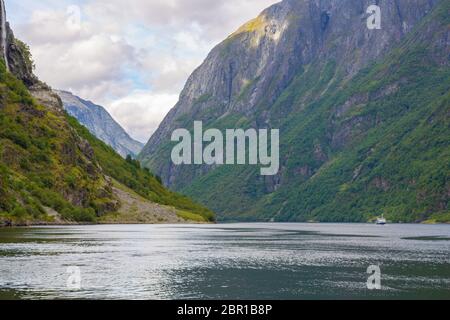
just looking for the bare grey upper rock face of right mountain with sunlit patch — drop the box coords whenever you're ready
[142,0,437,157]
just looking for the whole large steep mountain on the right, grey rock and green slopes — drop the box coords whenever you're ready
[139,0,450,222]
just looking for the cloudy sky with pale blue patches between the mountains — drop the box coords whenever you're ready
[6,0,278,142]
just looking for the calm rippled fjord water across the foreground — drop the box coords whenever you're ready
[0,223,450,299]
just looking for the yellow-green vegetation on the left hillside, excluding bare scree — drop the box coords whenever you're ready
[0,63,214,224]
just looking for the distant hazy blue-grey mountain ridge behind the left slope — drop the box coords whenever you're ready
[56,91,144,158]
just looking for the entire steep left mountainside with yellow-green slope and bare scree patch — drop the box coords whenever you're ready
[0,5,214,225]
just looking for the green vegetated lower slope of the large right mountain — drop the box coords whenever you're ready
[182,2,450,222]
